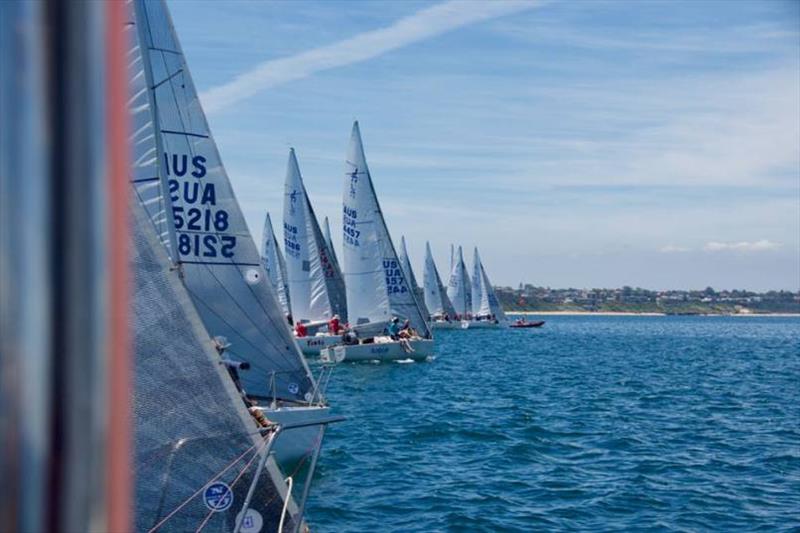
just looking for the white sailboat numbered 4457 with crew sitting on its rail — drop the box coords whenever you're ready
[321,122,434,361]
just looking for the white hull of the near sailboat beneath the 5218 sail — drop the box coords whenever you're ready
[260,405,330,470]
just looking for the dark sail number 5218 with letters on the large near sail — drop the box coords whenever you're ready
[164,154,236,259]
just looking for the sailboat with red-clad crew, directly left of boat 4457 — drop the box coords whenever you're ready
[283,149,347,355]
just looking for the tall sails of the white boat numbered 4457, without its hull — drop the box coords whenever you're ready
[342,122,430,337]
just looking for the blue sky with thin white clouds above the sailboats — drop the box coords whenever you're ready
[168,0,800,290]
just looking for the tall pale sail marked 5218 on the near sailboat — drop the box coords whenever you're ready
[128,0,314,401]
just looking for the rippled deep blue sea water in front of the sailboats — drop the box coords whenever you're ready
[308,316,800,532]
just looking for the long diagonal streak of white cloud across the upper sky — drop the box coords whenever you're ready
[200,0,538,112]
